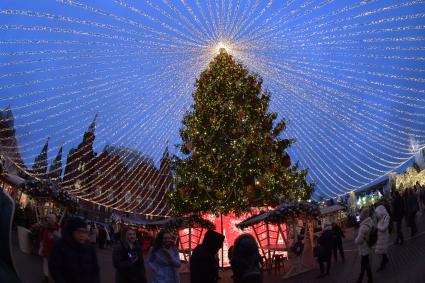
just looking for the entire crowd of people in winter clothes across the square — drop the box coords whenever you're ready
[20,183,425,283]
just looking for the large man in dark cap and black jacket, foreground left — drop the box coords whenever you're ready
[49,217,100,283]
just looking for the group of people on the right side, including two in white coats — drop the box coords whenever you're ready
[315,184,425,282]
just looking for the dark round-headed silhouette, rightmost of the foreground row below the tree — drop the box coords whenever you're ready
[230,234,263,283]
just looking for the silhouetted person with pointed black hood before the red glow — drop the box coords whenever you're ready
[190,230,224,283]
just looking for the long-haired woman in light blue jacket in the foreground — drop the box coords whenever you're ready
[148,230,181,283]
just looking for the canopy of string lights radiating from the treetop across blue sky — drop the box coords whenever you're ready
[0,0,425,215]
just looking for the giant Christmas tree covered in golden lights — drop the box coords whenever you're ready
[169,49,313,214]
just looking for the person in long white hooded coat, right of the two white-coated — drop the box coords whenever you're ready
[375,205,390,272]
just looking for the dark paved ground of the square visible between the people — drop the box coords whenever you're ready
[13,214,425,283]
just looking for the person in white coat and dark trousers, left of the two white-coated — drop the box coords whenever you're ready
[354,208,374,283]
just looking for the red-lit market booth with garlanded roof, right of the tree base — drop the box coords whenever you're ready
[236,201,320,278]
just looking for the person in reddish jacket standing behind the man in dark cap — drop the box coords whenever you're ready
[40,214,60,282]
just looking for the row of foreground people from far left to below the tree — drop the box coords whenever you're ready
[35,215,268,283]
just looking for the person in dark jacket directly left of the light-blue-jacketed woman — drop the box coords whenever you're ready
[112,229,147,283]
